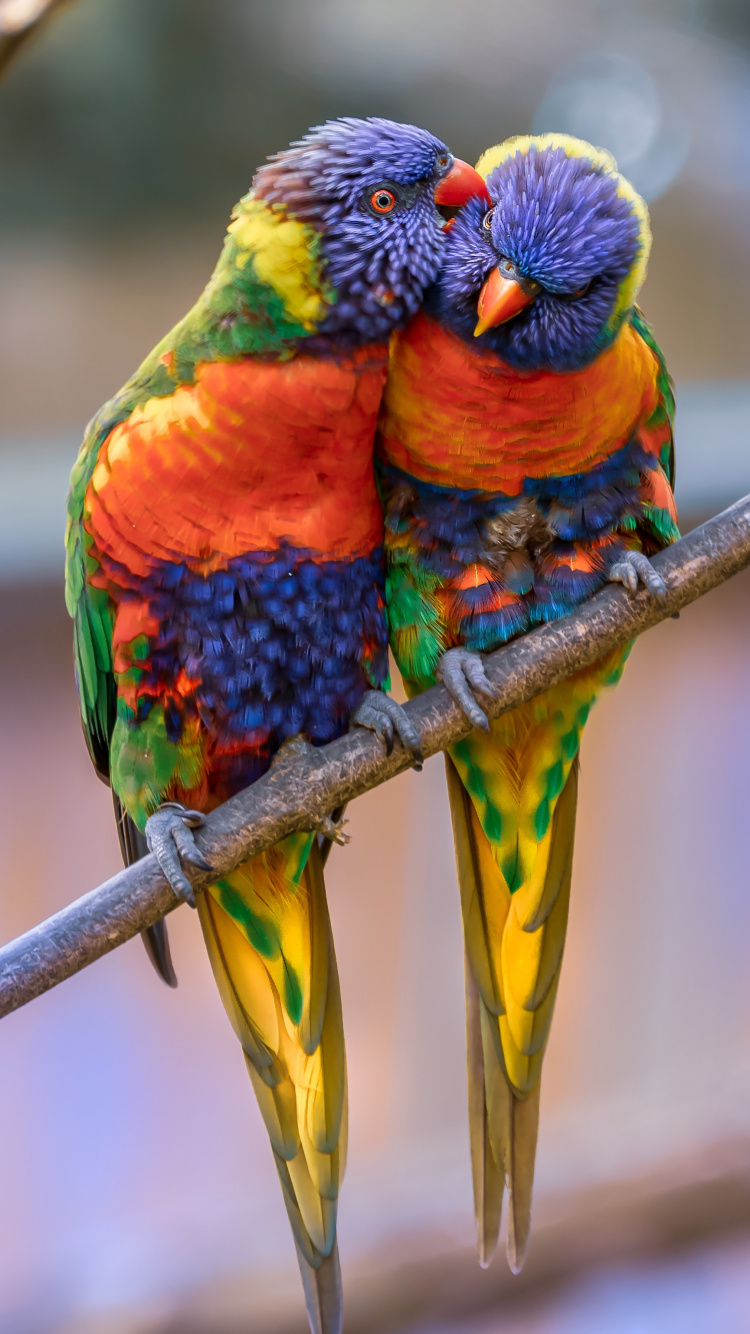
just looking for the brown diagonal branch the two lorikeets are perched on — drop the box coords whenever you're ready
[0,496,750,1017]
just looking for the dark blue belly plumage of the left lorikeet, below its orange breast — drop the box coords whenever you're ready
[119,546,388,795]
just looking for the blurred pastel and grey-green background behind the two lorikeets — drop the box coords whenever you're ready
[0,0,750,1334]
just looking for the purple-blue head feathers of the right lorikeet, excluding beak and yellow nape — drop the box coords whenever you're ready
[427,145,641,371]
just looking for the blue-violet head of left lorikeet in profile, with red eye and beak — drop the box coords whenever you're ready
[252,117,487,342]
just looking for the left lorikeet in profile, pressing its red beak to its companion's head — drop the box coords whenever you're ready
[67,119,482,1331]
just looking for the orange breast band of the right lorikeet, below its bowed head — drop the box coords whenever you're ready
[378,315,658,495]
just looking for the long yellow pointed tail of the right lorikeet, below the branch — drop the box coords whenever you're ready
[446,742,578,1273]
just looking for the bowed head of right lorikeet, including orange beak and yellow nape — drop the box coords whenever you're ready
[430,135,651,371]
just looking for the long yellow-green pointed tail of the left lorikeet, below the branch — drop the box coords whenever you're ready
[192,835,347,1334]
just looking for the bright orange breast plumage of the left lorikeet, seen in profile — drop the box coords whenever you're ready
[85,350,386,575]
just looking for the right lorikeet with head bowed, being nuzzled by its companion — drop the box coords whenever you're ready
[376,135,678,1271]
